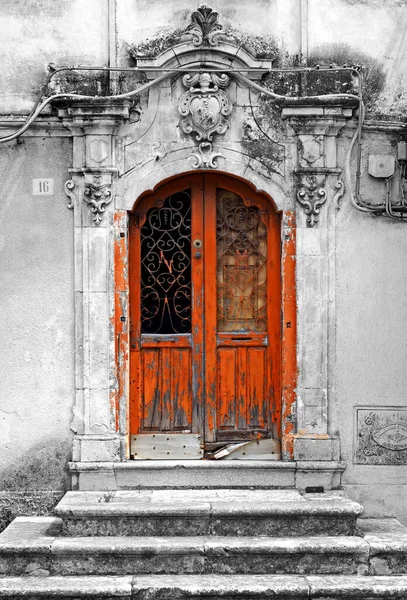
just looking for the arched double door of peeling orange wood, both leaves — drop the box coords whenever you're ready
[129,173,281,447]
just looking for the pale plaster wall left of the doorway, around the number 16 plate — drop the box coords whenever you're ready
[0,137,74,509]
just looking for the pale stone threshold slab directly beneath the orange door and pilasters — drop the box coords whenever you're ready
[69,460,346,491]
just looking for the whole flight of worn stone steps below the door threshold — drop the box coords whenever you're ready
[0,489,407,600]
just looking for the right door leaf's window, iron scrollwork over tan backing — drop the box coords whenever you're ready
[217,190,267,332]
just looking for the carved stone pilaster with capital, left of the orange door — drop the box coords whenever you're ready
[58,99,130,462]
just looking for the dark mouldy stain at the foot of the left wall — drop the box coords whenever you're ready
[0,439,72,531]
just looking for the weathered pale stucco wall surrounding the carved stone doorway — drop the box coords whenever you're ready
[0,0,407,522]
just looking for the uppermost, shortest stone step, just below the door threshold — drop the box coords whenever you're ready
[55,489,363,537]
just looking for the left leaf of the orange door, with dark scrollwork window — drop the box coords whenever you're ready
[130,178,203,434]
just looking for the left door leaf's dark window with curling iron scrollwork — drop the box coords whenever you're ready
[141,191,191,334]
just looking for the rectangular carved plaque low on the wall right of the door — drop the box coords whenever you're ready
[355,407,407,465]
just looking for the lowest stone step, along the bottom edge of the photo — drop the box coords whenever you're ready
[0,575,407,600]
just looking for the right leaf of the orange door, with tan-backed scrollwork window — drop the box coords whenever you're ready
[205,174,281,443]
